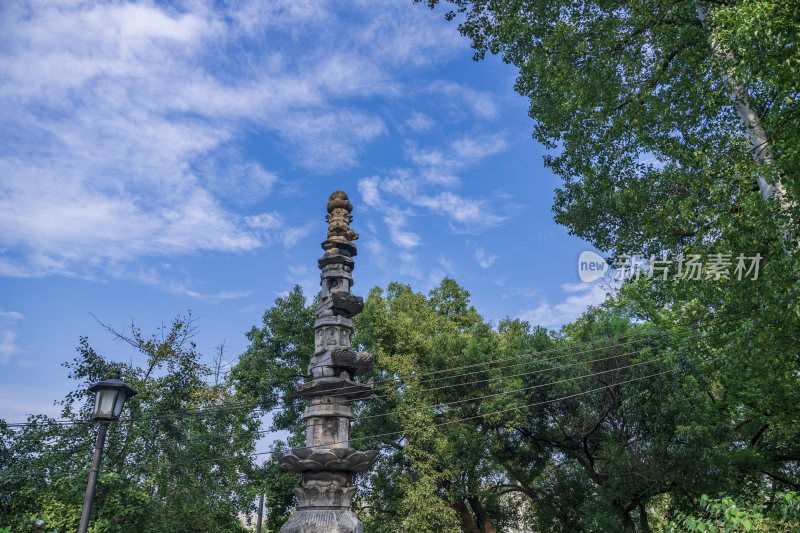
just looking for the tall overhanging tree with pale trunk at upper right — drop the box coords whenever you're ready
[418,0,800,520]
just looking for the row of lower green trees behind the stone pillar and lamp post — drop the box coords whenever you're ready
[0,279,797,533]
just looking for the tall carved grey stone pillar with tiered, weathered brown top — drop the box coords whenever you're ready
[275,191,378,533]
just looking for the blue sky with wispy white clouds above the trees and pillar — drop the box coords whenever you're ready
[0,0,604,421]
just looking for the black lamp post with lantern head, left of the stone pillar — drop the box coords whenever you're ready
[78,372,136,533]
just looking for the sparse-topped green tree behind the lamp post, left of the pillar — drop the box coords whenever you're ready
[0,317,260,533]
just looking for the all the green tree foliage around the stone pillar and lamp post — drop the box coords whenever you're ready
[0,0,800,533]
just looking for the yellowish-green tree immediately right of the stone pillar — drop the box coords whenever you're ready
[354,279,513,533]
